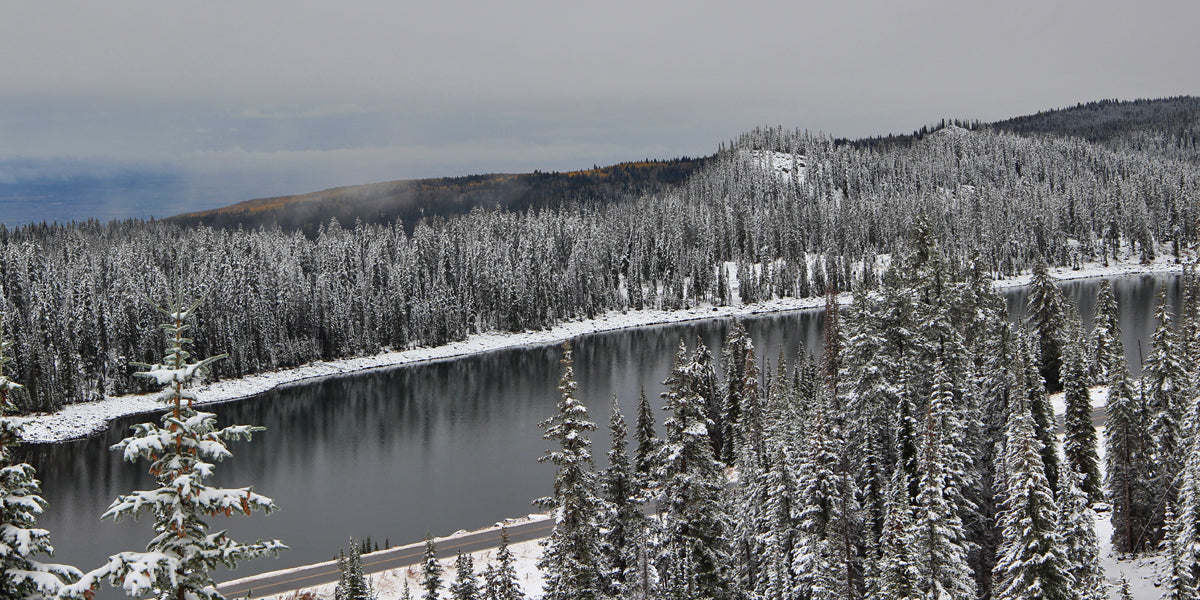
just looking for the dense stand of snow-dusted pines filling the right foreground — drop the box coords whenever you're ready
[540,230,1200,600]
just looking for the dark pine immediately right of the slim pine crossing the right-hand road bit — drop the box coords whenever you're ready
[1104,359,1154,553]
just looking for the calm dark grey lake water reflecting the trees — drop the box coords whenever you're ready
[23,276,1178,590]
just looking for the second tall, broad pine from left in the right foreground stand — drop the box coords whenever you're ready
[658,341,731,599]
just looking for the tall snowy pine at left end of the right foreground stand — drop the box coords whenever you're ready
[536,342,607,600]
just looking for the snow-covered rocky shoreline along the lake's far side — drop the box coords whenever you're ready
[12,254,1182,444]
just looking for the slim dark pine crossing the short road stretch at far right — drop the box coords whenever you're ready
[1062,342,1104,503]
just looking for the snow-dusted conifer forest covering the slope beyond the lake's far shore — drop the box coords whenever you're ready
[0,121,1200,410]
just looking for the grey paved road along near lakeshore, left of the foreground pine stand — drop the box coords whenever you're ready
[217,520,554,599]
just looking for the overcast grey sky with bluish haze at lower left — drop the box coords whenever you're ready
[0,0,1200,221]
